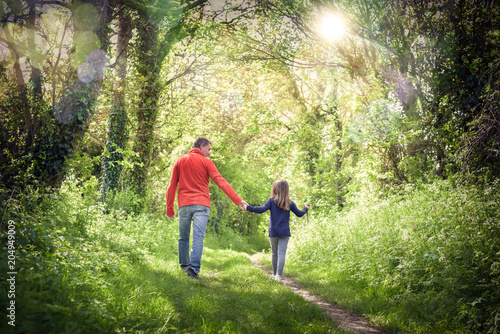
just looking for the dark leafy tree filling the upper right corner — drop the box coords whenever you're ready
[346,0,500,177]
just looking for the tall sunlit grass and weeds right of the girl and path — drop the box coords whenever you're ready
[287,179,500,333]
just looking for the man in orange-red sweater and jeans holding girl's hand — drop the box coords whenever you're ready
[167,137,247,279]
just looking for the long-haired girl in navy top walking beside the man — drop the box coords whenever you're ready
[246,180,309,282]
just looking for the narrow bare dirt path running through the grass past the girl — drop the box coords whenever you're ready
[248,255,384,334]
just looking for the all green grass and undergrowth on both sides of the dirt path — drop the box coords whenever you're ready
[0,178,500,333]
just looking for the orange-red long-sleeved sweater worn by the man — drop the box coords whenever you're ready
[167,148,241,216]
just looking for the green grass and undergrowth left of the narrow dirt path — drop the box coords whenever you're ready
[0,180,342,333]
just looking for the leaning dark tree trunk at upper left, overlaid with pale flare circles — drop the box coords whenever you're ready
[33,0,112,185]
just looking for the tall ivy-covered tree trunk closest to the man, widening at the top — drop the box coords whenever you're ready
[129,0,206,196]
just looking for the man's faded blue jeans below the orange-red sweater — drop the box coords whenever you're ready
[179,205,210,273]
